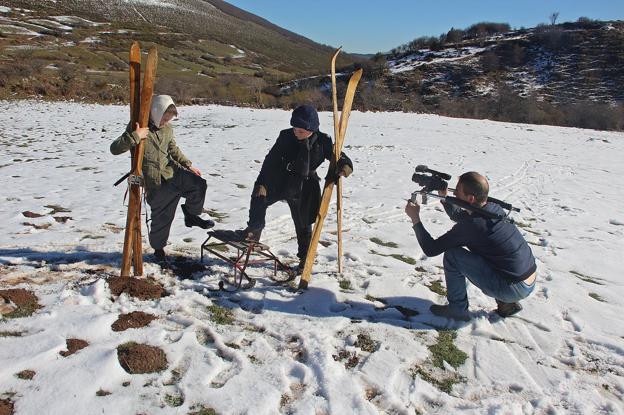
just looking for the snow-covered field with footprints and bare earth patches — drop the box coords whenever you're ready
[0,102,624,415]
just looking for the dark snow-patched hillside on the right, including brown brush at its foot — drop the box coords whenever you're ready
[286,20,624,129]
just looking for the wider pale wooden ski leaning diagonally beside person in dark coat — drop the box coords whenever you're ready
[299,69,362,290]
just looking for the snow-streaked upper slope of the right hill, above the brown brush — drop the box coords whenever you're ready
[388,22,624,103]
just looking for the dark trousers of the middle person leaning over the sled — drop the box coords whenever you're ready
[247,196,312,260]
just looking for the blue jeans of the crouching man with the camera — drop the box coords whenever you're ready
[444,248,535,313]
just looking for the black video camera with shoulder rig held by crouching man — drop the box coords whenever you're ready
[410,164,520,222]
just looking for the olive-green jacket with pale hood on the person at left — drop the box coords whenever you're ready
[110,95,192,191]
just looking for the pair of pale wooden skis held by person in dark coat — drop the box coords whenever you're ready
[299,48,362,289]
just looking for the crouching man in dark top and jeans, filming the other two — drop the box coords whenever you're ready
[405,172,536,321]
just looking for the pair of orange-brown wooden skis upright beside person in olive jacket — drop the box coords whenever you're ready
[121,47,158,277]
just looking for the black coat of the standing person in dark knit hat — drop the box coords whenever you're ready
[255,128,353,222]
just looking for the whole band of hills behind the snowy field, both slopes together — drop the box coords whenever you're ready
[0,0,624,130]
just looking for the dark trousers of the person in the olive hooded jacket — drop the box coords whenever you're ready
[146,169,207,249]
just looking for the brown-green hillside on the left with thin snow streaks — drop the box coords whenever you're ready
[0,0,352,106]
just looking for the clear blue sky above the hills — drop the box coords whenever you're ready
[227,0,624,53]
